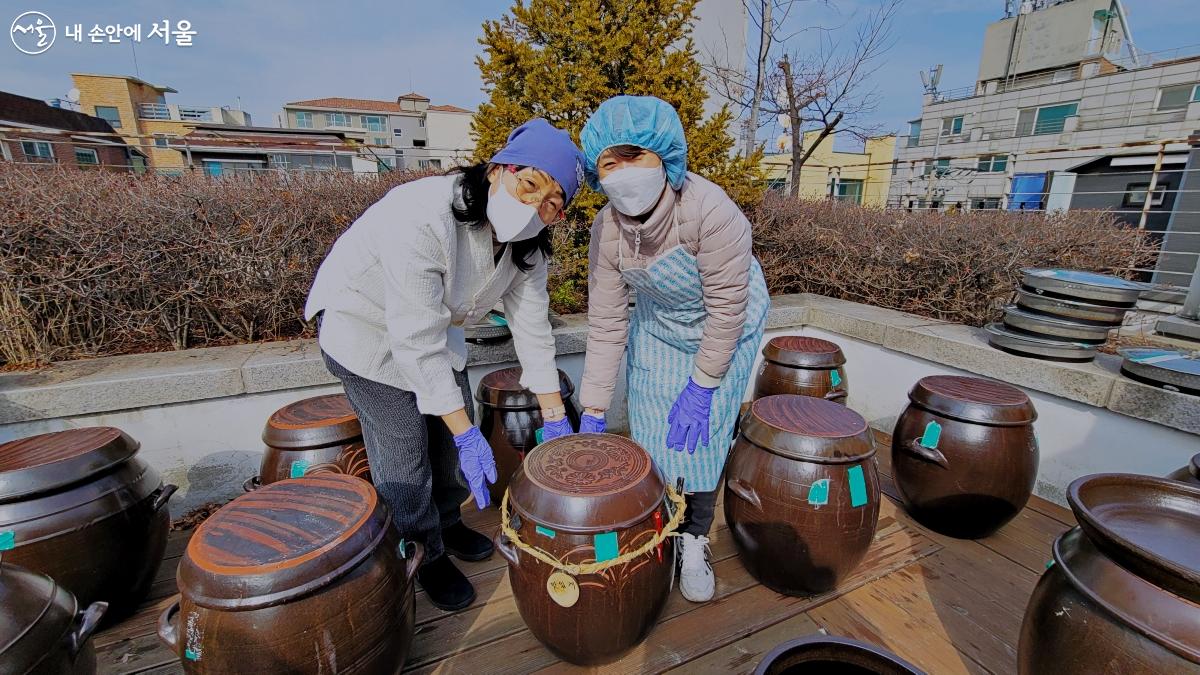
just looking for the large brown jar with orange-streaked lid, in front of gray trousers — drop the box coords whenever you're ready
[158,473,421,674]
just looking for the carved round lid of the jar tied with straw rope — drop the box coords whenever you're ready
[509,434,666,532]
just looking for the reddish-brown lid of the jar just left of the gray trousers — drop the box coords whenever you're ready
[263,394,362,450]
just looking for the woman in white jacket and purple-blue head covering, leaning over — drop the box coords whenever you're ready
[305,119,583,610]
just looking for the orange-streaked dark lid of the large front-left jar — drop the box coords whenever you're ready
[179,473,390,609]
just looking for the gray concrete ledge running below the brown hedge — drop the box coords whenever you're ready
[0,293,1200,435]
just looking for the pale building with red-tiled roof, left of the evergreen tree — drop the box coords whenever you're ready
[280,91,475,169]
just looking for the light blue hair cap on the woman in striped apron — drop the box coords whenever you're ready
[580,96,688,190]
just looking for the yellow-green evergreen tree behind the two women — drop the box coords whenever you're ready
[473,0,762,214]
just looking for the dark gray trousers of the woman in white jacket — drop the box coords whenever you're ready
[322,352,475,562]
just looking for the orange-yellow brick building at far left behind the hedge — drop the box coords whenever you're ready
[71,73,251,173]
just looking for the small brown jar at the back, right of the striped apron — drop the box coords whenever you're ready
[754,335,847,404]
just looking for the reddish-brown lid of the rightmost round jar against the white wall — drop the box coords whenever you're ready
[908,375,1038,426]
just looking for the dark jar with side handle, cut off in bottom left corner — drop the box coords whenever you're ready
[0,563,108,675]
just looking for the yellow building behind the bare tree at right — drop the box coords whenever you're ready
[760,131,896,207]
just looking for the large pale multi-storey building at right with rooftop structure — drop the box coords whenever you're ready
[888,0,1200,209]
